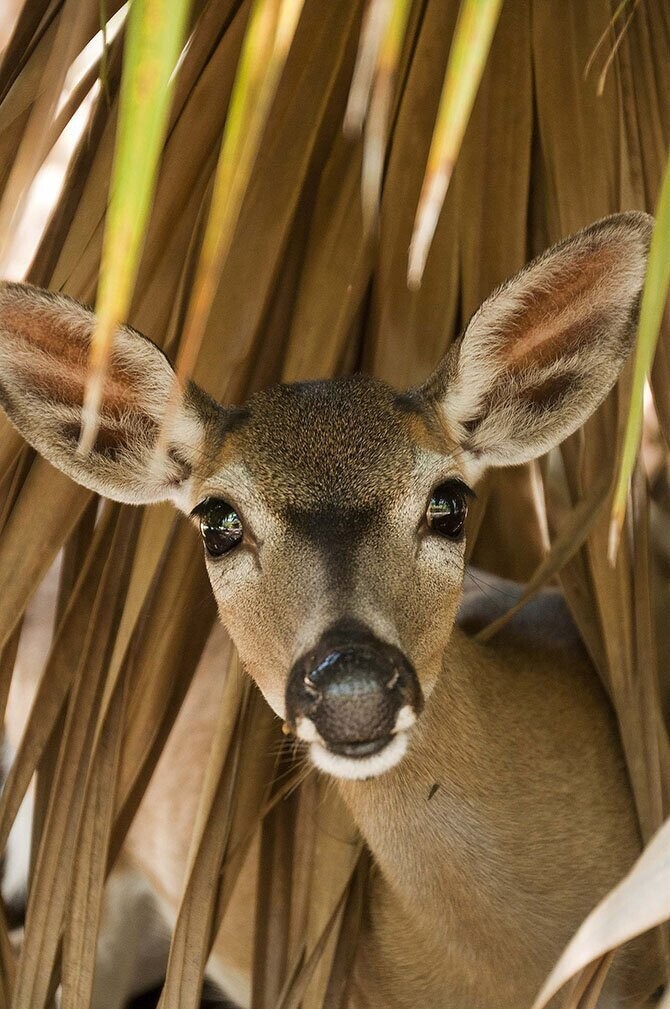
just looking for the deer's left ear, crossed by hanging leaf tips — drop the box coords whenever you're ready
[0,284,225,510]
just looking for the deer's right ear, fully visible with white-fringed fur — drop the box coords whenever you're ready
[420,213,653,478]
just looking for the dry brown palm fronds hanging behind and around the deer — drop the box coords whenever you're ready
[0,0,670,1009]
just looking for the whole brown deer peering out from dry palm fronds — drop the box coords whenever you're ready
[0,212,663,1009]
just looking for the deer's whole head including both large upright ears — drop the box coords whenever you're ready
[0,214,650,777]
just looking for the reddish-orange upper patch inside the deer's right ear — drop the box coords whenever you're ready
[499,246,618,371]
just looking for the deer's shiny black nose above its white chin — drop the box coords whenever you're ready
[287,621,423,757]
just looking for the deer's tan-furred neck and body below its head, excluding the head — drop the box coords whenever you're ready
[340,632,661,1009]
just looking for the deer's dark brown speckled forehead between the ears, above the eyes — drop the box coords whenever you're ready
[197,375,450,516]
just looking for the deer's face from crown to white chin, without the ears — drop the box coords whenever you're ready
[188,376,470,776]
